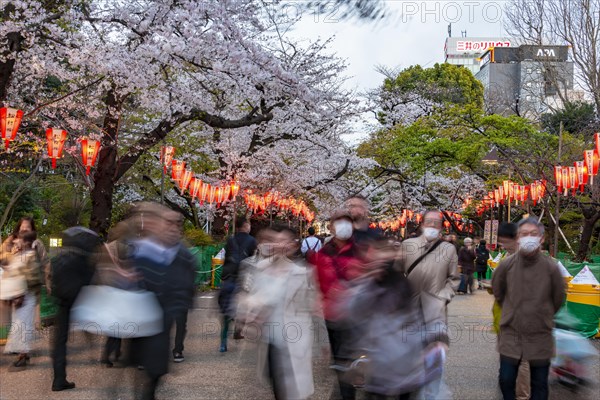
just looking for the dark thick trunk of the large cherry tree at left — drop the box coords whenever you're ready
[90,90,123,237]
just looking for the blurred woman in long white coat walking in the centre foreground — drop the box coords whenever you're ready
[238,227,314,400]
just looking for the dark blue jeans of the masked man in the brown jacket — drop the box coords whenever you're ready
[500,356,550,400]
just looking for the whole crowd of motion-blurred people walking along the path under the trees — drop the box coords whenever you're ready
[3,196,584,400]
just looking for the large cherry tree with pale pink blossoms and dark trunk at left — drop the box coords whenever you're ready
[0,0,372,233]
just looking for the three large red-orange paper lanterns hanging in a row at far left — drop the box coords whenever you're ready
[0,107,101,175]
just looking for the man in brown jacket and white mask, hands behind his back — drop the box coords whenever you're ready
[492,218,565,399]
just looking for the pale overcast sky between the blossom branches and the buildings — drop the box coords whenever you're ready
[286,0,506,142]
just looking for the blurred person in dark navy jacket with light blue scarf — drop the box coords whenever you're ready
[130,203,196,400]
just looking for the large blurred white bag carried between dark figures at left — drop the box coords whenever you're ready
[71,285,164,339]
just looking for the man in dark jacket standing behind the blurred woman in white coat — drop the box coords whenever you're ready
[219,218,256,352]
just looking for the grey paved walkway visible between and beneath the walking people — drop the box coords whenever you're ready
[0,291,600,400]
